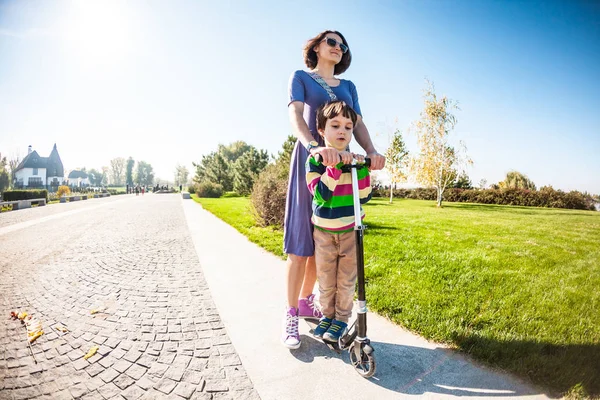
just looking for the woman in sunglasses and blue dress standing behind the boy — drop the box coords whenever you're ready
[282,31,385,349]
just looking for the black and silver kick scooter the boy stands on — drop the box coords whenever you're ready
[307,156,375,378]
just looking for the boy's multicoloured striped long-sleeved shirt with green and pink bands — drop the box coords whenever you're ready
[306,156,371,233]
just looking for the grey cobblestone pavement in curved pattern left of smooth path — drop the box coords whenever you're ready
[0,194,259,400]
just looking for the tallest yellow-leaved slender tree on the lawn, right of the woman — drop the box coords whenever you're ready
[411,81,472,207]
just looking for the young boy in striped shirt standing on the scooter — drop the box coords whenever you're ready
[306,101,371,342]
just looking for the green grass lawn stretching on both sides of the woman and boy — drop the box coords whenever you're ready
[191,198,600,396]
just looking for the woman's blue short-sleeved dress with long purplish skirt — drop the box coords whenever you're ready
[283,71,362,257]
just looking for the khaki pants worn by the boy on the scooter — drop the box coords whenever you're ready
[313,228,356,323]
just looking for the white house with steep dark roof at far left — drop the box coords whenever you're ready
[14,143,65,188]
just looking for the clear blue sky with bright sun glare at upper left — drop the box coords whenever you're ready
[0,0,600,193]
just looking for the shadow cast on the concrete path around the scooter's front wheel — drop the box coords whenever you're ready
[291,335,564,398]
